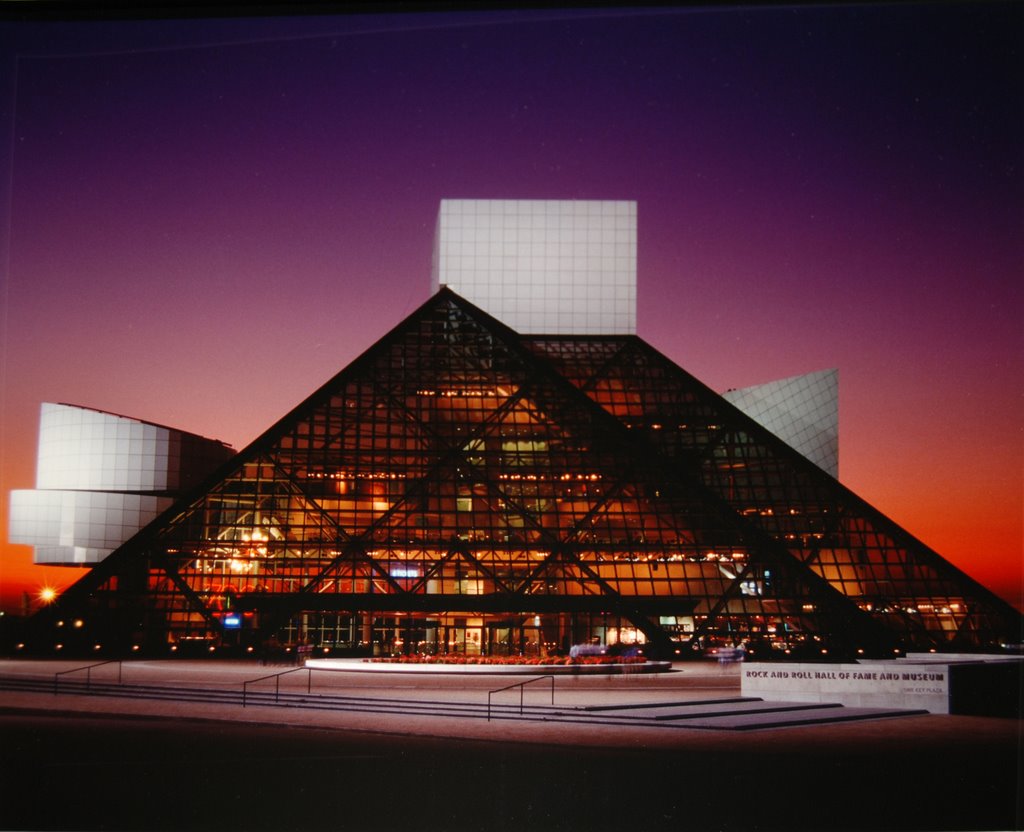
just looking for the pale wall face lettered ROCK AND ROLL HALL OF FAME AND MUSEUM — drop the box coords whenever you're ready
[740,662,949,713]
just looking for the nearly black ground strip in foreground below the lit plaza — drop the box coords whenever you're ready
[0,711,1024,832]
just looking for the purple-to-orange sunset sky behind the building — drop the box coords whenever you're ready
[0,3,1024,604]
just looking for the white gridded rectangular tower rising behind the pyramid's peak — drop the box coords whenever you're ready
[431,200,637,335]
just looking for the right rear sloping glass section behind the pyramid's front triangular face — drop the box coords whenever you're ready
[530,336,1020,649]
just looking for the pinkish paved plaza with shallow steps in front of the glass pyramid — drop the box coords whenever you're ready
[0,660,1016,747]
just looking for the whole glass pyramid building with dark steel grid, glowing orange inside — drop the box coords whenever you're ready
[36,288,1021,658]
